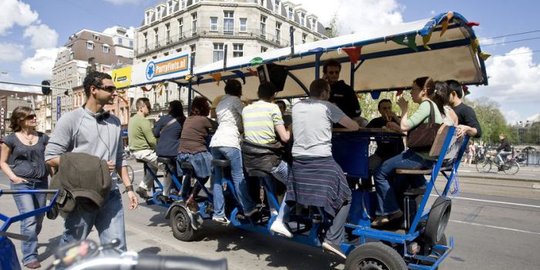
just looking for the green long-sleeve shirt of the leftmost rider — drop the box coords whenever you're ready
[128,114,156,151]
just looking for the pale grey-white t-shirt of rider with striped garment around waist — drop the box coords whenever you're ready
[292,99,345,157]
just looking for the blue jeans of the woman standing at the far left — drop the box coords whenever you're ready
[11,180,48,265]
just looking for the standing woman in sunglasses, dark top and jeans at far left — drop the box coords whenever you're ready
[0,107,49,269]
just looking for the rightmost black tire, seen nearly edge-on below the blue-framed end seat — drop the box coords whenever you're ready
[423,197,452,246]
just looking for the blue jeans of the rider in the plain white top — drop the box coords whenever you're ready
[210,147,255,217]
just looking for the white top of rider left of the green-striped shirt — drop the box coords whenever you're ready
[210,95,244,149]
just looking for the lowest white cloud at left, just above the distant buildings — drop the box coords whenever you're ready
[21,48,60,79]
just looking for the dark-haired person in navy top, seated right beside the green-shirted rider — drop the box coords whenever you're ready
[152,100,186,197]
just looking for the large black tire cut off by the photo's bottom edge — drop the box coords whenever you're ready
[345,242,407,270]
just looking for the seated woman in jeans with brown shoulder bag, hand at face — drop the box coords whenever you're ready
[371,77,452,226]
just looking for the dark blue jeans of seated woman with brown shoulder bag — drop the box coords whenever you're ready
[373,149,434,216]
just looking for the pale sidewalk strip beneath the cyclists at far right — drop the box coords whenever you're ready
[459,164,540,183]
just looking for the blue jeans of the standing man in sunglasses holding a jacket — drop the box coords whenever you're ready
[60,189,127,251]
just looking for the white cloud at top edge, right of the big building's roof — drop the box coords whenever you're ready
[294,0,404,36]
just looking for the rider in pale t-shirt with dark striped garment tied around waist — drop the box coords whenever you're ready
[287,79,359,258]
